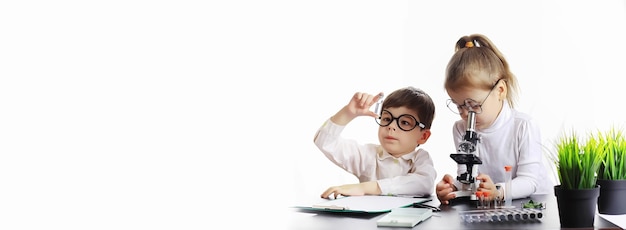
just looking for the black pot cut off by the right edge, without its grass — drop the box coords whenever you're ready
[596,179,626,215]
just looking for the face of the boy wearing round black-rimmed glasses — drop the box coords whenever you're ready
[378,106,430,157]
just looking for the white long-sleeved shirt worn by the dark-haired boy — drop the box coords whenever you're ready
[314,119,437,195]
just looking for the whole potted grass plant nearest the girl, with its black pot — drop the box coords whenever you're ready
[552,132,603,228]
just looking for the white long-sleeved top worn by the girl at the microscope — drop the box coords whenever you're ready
[452,100,554,199]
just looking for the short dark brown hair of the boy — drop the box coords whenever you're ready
[383,86,435,129]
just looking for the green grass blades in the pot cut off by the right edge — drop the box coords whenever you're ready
[598,127,626,180]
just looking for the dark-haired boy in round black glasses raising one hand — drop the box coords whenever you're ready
[314,87,437,198]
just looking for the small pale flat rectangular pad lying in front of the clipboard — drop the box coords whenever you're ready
[376,208,433,228]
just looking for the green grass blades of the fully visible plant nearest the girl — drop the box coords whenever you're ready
[552,131,604,189]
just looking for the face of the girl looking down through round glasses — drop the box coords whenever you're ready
[447,81,506,130]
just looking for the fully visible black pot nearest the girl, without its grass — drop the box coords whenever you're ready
[554,185,600,228]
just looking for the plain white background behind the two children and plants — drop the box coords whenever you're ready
[0,0,626,229]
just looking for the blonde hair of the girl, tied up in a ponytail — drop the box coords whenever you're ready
[444,34,519,108]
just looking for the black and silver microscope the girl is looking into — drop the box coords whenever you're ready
[450,111,482,201]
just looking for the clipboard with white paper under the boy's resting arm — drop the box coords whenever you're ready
[296,195,432,213]
